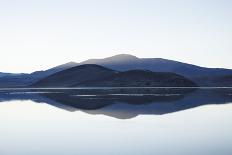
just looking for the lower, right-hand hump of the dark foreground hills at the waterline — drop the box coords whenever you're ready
[75,70,196,87]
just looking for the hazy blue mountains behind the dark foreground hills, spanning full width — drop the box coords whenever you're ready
[0,54,232,87]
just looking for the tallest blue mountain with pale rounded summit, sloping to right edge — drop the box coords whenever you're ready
[81,54,232,86]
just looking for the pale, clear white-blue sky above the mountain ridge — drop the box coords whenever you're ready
[0,0,232,73]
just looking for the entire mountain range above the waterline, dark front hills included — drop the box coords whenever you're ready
[0,54,232,87]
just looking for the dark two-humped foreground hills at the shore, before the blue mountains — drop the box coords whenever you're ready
[32,64,197,87]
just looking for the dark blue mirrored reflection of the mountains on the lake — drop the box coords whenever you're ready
[0,88,232,119]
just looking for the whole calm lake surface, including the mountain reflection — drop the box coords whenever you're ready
[0,88,232,155]
